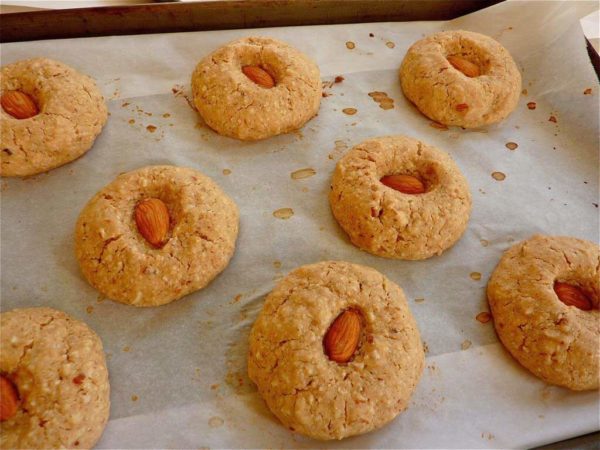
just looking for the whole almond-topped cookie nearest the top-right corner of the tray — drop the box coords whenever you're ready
[400,30,521,128]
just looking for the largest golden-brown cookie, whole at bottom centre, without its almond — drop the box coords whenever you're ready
[248,261,424,440]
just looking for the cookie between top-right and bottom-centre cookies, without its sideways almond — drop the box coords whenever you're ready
[329,136,471,259]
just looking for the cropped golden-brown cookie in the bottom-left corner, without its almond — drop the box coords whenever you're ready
[0,308,110,449]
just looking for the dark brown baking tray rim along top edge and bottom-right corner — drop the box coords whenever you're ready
[0,1,598,448]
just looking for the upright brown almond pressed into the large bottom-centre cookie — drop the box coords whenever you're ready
[323,309,362,363]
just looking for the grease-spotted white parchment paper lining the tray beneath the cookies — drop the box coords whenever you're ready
[1,2,599,448]
